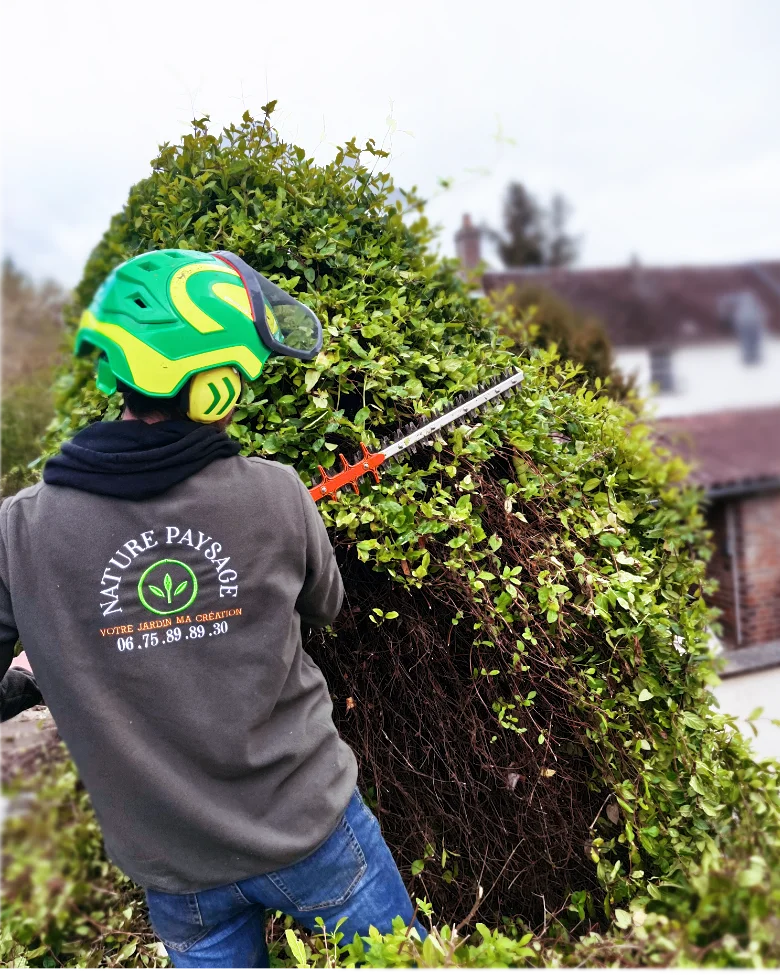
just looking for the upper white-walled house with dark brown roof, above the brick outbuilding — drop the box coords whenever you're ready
[483,262,780,417]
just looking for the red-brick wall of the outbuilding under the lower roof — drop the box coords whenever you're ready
[708,492,780,647]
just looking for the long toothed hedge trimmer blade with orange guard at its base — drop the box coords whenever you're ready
[309,369,523,502]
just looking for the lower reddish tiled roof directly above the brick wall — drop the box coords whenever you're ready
[655,407,780,493]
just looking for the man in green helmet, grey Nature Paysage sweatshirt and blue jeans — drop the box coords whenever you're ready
[0,250,424,969]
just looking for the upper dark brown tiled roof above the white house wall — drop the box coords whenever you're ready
[483,261,780,346]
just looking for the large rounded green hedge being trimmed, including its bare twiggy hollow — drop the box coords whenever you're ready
[6,103,779,964]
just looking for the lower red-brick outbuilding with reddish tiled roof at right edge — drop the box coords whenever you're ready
[657,406,780,758]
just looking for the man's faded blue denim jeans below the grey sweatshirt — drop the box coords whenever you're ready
[146,790,426,969]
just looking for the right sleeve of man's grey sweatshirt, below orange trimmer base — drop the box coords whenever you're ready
[295,475,344,627]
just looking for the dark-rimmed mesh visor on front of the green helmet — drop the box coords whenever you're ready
[213,251,322,360]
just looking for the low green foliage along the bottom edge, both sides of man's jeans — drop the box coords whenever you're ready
[0,761,780,973]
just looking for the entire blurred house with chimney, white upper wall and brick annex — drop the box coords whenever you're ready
[456,220,780,756]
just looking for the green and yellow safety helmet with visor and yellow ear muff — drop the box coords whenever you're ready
[75,249,322,422]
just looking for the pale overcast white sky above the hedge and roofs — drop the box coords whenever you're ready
[0,0,780,284]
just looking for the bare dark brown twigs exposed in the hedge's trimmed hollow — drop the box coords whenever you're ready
[307,464,604,924]
